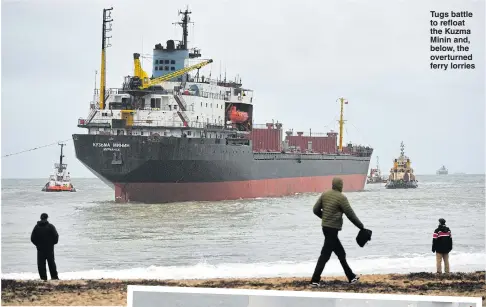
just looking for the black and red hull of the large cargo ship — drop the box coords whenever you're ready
[73,134,370,203]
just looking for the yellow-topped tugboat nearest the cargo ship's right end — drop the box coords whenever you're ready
[385,142,418,189]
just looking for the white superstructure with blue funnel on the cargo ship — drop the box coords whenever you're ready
[78,10,253,138]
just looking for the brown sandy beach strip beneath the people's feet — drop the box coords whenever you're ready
[2,271,486,306]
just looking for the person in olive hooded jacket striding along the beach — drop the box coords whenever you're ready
[311,177,364,287]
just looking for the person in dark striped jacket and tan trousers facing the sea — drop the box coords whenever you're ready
[432,218,452,274]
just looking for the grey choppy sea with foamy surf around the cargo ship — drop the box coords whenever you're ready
[1,175,486,279]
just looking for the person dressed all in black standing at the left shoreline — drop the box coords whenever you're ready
[30,213,59,280]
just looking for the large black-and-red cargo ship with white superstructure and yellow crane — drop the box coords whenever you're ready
[73,8,373,203]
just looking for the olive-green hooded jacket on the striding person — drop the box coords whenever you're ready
[313,177,364,230]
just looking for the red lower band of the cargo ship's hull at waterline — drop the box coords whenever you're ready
[115,174,366,203]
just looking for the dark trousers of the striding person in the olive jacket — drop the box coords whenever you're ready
[311,227,356,282]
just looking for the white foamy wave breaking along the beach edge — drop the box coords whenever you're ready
[2,252,486,280]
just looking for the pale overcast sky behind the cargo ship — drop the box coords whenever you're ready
[1,0,485,178]
